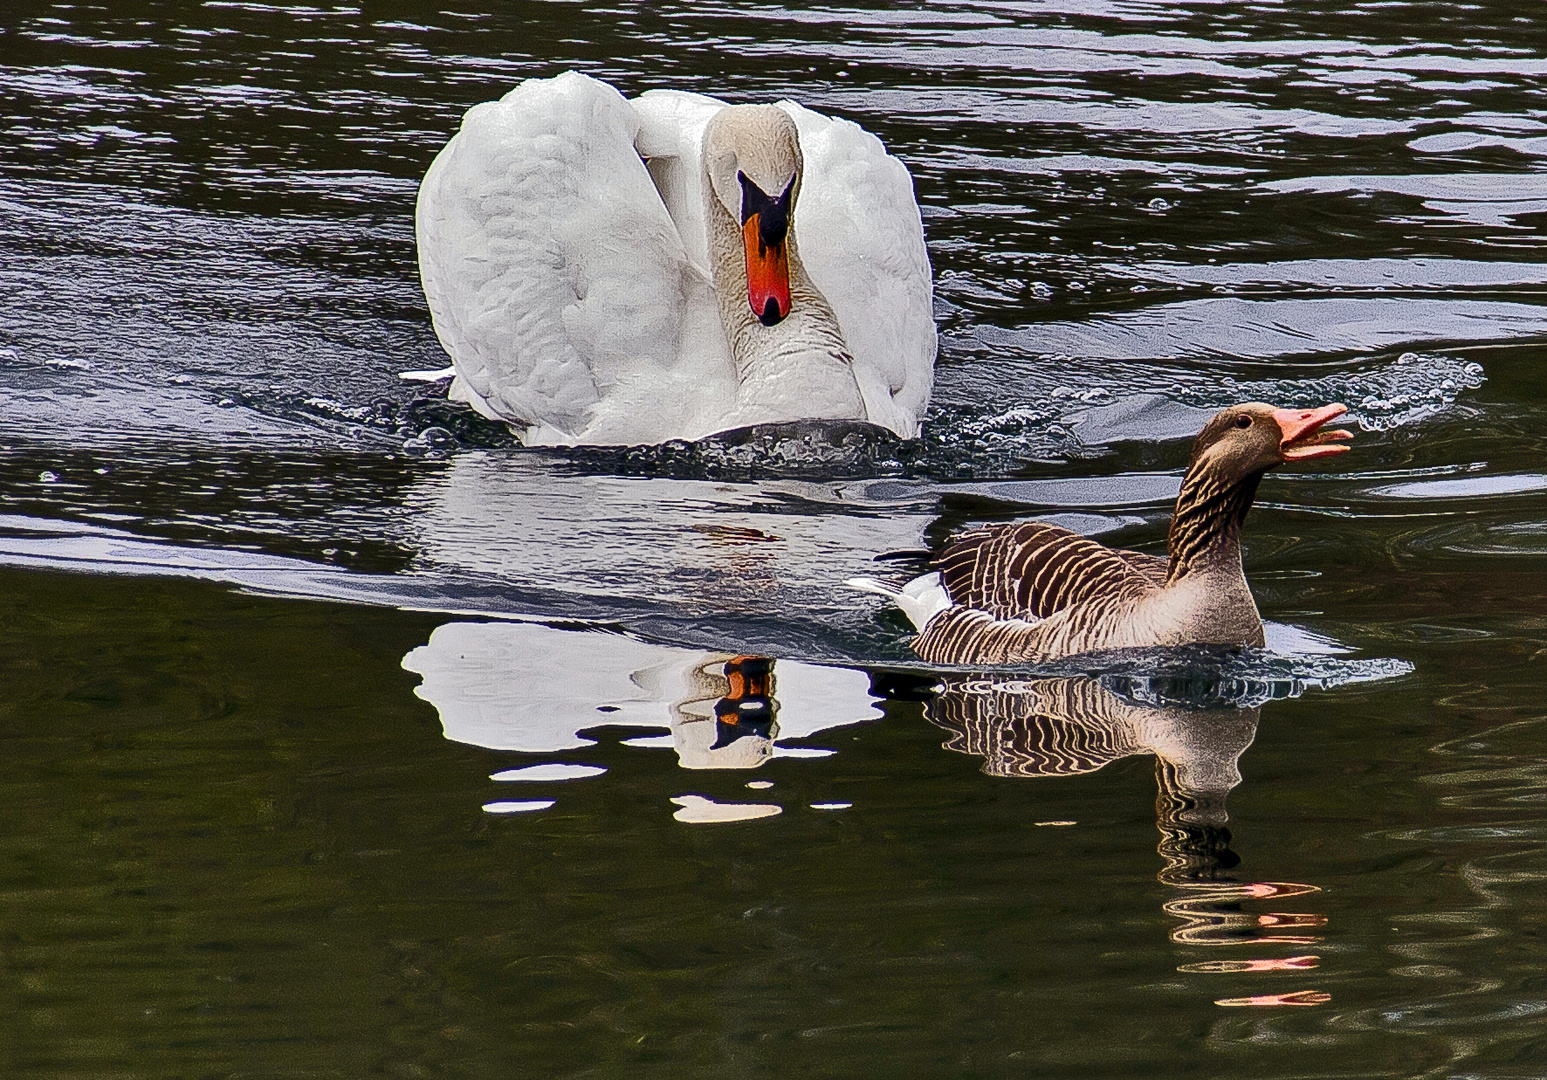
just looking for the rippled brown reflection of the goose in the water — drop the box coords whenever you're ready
[925,676,1327,1006]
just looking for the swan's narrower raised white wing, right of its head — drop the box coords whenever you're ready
[780,101,936,438]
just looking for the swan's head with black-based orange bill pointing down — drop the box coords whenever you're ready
[704,105,801,326]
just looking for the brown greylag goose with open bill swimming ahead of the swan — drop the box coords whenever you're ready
[849,402,1352,664]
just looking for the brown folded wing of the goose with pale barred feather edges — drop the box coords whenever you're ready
[936,521,1165,620]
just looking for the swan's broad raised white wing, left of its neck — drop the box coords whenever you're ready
[416,73,733,443]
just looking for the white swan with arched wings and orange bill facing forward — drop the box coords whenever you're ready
[416,71,936,444]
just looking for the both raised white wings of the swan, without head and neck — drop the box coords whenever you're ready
[416,73,936,443]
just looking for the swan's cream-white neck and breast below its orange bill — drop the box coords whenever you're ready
[704,175,866,422]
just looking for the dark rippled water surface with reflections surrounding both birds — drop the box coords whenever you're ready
[0,0,1547,1078]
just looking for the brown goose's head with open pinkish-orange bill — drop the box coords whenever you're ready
[1188,401,1354,483]
